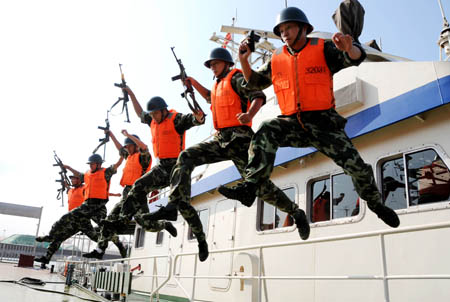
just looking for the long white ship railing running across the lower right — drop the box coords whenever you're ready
[172,222,450,302]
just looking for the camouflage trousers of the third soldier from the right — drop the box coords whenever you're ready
[117,162,176,232]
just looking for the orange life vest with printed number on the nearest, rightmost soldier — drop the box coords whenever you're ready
[271,38,334,115]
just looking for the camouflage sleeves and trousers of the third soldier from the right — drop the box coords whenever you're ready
[114,112,204,232]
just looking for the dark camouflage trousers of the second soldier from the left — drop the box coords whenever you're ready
[45,199,121,259]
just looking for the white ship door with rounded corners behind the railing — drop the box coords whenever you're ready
[209,199,236,290]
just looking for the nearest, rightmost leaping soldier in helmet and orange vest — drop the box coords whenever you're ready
[219,7,400,227]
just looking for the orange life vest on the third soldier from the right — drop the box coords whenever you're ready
[150,110,185,159]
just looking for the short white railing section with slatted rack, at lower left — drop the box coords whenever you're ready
[59,254,173,300]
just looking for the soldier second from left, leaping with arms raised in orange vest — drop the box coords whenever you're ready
[34,154,126,265]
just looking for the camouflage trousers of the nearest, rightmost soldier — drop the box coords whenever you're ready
[245,109,381,207]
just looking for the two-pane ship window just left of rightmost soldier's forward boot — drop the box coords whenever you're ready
[309,173,359,222]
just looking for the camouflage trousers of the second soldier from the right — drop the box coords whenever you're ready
[169,137,298,241]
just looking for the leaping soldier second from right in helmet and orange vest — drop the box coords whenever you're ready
[145,48,309,261]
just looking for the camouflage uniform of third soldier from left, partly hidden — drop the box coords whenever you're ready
[97,147,154,251]
